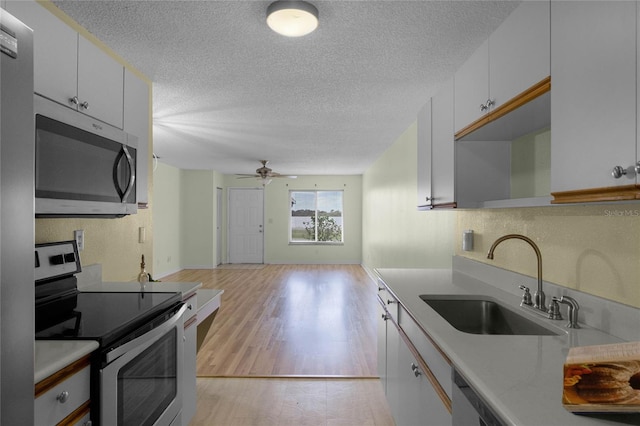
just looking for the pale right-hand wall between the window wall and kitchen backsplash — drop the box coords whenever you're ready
[362,123,456,270]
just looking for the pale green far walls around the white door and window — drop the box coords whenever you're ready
[153,163,362,270]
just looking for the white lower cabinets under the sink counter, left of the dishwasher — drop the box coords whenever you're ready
[378,284,451,426]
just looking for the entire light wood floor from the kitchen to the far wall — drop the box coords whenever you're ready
[163,265,394,426]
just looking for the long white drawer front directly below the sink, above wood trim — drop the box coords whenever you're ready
[398,306,453,398]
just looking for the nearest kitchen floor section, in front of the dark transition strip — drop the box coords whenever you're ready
[189,378,394,426]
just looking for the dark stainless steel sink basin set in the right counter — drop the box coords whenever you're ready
[420,295,559,336]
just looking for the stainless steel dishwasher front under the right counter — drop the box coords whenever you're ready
[452,369,506,426]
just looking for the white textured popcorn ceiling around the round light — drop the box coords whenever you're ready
[53,0,519,175]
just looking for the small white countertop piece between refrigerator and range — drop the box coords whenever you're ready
[33,340,98,384]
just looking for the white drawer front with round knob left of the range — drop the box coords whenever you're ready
[35,366,91,426]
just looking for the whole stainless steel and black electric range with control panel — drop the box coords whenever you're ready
[35,241,186,426]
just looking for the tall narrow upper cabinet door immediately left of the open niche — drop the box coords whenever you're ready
[431,79,456,210]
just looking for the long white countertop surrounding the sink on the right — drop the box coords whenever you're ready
[377,269,640,426]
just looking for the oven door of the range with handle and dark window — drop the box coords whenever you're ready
[99,304,187,426]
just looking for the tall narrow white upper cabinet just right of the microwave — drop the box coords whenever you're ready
[123,69,151,204]
